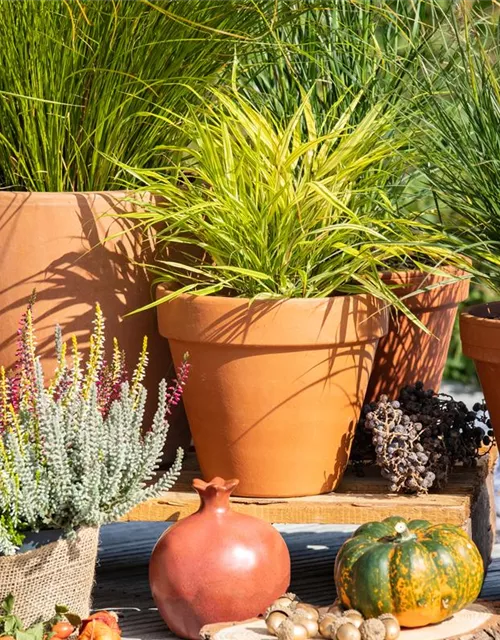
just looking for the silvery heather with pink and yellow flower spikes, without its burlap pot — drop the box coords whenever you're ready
[0,303,189,554]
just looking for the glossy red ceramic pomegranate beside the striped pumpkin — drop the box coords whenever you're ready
[149,478,290,640]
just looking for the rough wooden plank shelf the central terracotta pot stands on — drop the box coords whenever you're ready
[124,455,494,531]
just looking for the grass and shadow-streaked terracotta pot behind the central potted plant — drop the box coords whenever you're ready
[235,0,469,402]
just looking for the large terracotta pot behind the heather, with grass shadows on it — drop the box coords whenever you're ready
[0,191,189,459]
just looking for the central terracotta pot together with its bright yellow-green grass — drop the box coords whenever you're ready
[122,82,468,496]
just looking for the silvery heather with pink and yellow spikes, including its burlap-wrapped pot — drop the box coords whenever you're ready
[0,298,188,625]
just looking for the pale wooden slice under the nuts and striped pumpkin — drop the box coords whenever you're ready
[200,602,500,640]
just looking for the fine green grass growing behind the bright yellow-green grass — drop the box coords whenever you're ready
[232,0,466,258]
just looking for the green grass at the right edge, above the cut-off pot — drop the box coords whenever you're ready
[415,12,500,292]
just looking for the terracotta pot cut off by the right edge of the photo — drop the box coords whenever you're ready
[460,302,500,442]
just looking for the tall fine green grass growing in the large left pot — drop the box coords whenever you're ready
[0,0,287,191]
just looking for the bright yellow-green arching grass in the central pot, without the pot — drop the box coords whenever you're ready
[120,87,468,320]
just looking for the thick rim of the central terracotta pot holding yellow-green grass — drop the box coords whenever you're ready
[157,288,389,349]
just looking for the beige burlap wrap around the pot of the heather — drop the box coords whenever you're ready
[0,528,99,626]
